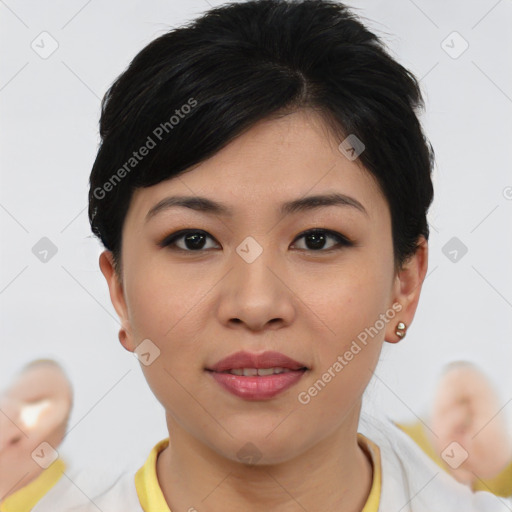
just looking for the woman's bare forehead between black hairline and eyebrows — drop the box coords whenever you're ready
[126,110,388,222]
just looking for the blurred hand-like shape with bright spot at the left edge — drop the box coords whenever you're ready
[0,361,72,502]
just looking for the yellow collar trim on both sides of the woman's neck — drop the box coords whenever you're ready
[135,433,382,512]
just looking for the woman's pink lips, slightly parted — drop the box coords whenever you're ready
[207,352,308,400]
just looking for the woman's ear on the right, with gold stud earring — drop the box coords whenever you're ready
[385,235,428,343]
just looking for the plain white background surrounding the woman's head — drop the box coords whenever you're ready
[0,0,512,476]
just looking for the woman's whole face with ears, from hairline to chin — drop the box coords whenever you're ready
[100,111,426,463]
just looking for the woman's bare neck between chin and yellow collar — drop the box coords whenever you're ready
[157,409,372,512]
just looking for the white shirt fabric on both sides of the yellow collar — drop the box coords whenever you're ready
[66,413,512,512]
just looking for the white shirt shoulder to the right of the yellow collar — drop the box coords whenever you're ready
[359,414,512,512]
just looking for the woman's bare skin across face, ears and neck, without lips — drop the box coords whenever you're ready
[100,110,428,512]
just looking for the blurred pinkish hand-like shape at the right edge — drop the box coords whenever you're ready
[429,363,512,485]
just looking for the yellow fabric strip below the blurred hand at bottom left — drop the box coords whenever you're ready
[0,459,66,512]
